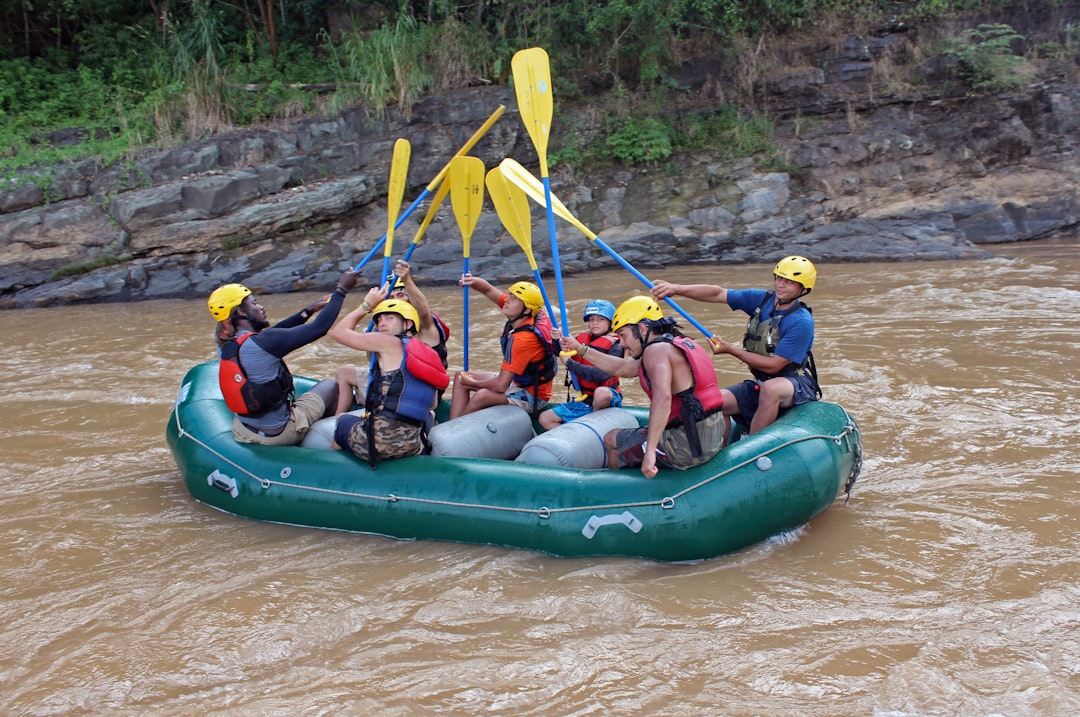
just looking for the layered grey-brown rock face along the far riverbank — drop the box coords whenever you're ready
[0,19,1080,308]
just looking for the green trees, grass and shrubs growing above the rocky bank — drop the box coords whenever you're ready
[0,0,1078,176]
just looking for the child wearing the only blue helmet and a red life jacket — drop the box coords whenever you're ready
[540,299,622,431]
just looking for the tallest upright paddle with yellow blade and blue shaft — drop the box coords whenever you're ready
[510,48,570,335]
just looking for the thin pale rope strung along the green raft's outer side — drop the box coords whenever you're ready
[173,402,862,518]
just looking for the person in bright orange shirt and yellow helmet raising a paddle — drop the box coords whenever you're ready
[450,274,556,419]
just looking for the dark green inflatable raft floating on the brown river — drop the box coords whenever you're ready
[166,362,862,562]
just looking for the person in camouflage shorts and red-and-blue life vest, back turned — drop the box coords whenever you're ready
[330,295,450,468]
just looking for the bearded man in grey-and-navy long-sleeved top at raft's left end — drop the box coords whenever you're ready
[207,271,356,446]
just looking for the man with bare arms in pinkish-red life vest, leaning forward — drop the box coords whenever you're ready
[563,296,726,478]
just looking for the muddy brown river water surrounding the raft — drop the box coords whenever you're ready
[0,240,1080,717]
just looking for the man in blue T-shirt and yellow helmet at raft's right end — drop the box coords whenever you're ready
[652,256,821,434]
